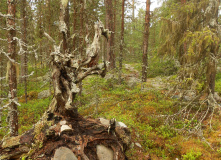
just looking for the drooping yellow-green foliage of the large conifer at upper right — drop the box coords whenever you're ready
[158,0,220,94]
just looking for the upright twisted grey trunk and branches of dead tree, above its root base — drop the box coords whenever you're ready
[52,0,109,116]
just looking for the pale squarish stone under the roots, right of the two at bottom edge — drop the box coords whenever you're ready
[97,145,114,160]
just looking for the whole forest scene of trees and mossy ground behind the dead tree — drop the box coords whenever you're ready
[0,0,221,160]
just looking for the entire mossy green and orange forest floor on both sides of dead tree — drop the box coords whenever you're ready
[0,64,221,160]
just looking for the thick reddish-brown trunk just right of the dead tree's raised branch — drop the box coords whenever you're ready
[105,0,115,69]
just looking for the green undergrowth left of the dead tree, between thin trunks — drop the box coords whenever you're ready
[0,67,52,138]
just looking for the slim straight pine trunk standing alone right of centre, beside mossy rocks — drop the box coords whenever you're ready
[142,0,150,82]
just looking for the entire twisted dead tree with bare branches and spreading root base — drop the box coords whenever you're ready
[0,0,130,160]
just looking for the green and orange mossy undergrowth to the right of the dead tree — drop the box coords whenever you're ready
[79,77,221,160]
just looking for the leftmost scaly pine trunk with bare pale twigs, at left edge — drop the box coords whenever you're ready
[7,0,18,136]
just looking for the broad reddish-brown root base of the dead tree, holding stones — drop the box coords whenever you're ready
[0,109,130,160]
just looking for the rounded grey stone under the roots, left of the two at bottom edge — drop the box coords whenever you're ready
[54,147,78,160]
